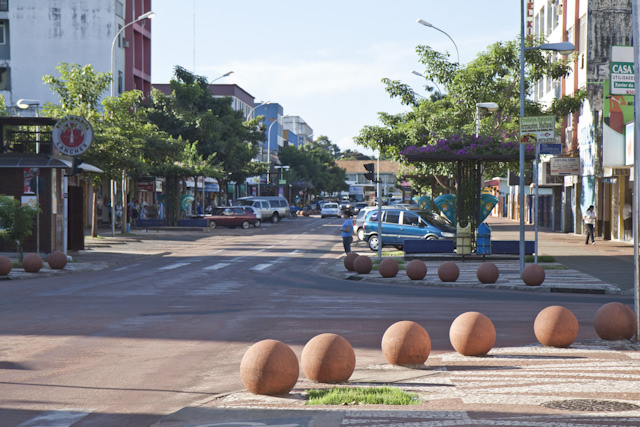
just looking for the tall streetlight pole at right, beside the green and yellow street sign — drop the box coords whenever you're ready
[518,0,576,274]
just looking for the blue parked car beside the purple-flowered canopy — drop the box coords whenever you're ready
[363,208,456,251]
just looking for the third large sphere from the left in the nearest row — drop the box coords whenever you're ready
[382,320,431,365]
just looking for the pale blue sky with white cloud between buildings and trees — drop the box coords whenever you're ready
[152,0,520,154]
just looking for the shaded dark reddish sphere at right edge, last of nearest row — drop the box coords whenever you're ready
[593,302,637,340]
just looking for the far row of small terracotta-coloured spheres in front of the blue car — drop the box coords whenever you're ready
[344,252,545,286]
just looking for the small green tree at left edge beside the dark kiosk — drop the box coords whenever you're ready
[0,194,40,263]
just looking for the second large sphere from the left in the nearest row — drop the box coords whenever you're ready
[300,334,356,384]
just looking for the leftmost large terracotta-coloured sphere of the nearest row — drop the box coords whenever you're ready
[240,340,299,395]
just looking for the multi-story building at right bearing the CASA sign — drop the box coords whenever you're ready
[529,0,633,240]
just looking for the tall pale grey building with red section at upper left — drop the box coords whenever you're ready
[0,0,151,113]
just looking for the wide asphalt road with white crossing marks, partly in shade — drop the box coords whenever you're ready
[0,219,630,426]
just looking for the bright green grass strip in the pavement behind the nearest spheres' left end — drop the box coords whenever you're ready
[307,386,420,405]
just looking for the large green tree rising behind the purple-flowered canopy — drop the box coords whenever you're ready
[355,37,576,193]
